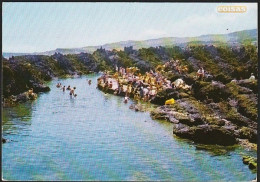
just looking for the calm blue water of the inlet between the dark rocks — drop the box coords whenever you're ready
[2,75,256,181]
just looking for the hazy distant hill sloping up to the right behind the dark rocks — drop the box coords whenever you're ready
[3,29,258,58]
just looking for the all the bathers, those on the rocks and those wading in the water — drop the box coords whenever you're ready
[56,60,255,103]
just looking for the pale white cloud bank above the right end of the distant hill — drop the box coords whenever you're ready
[168,4,257,37]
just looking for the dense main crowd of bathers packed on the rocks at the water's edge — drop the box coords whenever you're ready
[98,64,190,102]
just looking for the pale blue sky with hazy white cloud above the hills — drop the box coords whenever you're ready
[2,2,257,53]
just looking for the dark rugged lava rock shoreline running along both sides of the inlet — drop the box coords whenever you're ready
[2,45,258,171]
